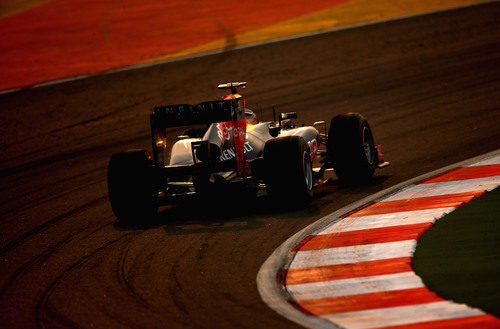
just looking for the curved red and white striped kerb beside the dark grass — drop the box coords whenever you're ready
[283,155,500,329]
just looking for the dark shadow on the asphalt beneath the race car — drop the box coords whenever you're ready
[115,176,387,235]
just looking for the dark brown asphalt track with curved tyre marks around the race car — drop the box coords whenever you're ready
[0,2,500,328]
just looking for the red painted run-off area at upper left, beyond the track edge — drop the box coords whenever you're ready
[0,0,347,90]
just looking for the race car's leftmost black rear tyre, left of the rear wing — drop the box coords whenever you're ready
[108,150,158,223]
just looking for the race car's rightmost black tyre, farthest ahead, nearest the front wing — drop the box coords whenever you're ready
[327,113,377,185]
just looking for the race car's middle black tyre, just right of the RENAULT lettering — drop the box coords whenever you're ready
[264,136,313,203]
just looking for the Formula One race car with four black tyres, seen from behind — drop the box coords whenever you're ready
[108,82,389,221]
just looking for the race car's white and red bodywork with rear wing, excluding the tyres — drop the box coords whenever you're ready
[150,83,320,199]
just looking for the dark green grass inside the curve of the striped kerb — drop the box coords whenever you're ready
[413,188,500,317]
